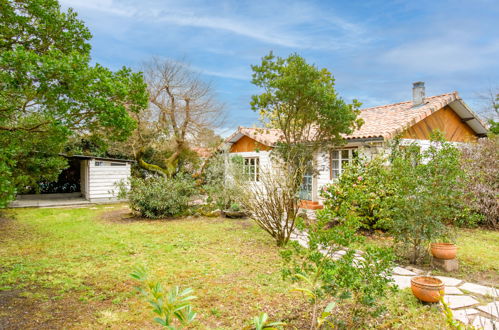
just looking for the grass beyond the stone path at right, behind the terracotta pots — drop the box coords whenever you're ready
[360,228,499,286]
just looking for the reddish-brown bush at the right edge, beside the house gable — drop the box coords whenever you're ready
[462,136,499,229]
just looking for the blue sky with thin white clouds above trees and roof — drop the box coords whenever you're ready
[60,0,499,135]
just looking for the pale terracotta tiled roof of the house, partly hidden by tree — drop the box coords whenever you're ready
[226,92,474,146]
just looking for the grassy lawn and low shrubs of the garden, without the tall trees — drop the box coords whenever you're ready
[0,127,499,329]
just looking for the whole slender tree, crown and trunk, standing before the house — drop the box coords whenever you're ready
[241,52,361,245]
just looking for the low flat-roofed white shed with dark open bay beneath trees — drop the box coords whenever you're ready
[9,155,133,207]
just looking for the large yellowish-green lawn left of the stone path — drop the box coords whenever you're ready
[0,205,452,329]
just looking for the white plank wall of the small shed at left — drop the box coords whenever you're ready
[86,159,131,202]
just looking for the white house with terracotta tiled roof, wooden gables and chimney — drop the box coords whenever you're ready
[225,82,487,209]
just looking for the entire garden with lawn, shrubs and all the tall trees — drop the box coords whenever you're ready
[0,0,499,329]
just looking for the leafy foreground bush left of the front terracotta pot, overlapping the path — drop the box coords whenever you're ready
[281,205,394,329]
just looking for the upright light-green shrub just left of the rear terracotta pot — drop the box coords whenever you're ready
[385,134,464,263]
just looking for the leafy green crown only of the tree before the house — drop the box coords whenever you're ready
[251,52,361,149]
